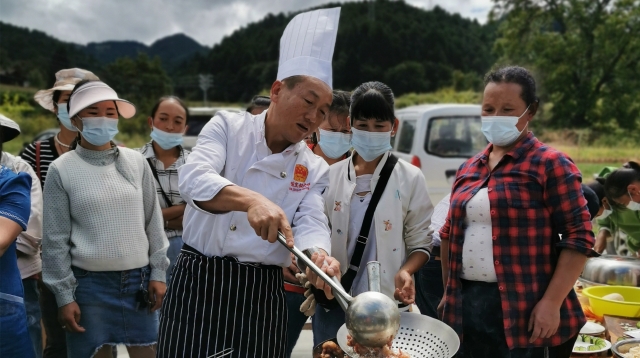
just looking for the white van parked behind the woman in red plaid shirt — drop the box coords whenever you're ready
[391,104,488,205]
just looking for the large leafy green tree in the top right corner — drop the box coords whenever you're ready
[491,0,640,129]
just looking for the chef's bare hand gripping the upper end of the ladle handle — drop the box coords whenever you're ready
[247,200,293,247]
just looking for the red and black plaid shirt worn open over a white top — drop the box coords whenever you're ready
[440,133,595,349]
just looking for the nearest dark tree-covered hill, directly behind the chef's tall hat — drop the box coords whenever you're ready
[192,0,496,101]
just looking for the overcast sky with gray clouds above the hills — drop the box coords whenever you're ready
[0,0,492,46]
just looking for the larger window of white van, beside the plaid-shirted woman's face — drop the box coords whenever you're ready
[424,116,488,158]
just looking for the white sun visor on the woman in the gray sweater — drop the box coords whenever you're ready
[69,81,136,118]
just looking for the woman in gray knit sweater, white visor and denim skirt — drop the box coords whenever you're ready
[42,81,169,358]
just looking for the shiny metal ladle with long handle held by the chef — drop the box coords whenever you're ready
[278,232,400,348]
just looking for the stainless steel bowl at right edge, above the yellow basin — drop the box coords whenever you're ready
[580,255,640,287]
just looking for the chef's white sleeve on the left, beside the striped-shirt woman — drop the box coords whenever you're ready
[178,114,234,212]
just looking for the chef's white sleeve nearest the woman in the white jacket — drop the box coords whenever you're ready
[292,165,331,255]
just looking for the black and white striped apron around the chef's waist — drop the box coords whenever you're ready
[157,245,287,358]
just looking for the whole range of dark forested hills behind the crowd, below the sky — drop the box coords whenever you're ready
[0,0,497,102]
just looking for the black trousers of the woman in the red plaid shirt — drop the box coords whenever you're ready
[456,280,578,358]
